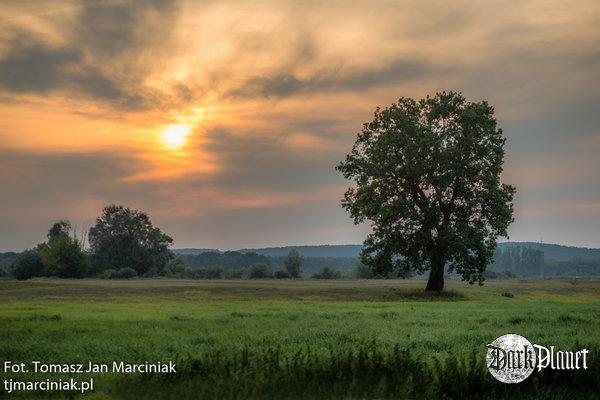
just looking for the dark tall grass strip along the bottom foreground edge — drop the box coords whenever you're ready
[113,342,600,399]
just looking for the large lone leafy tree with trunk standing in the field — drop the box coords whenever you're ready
[337,92,515,290]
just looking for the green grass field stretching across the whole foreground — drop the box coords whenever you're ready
[0,279,600,399]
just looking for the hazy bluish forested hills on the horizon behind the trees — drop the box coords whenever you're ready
[0,242,600,279]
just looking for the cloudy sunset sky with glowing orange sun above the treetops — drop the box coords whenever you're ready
[0,0,600,250]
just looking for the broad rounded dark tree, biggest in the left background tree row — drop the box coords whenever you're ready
[89,205,173,275]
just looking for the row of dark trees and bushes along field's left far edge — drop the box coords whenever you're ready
[0,205,324,279]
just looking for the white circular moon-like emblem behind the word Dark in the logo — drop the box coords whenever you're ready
[485,333,537,383]
